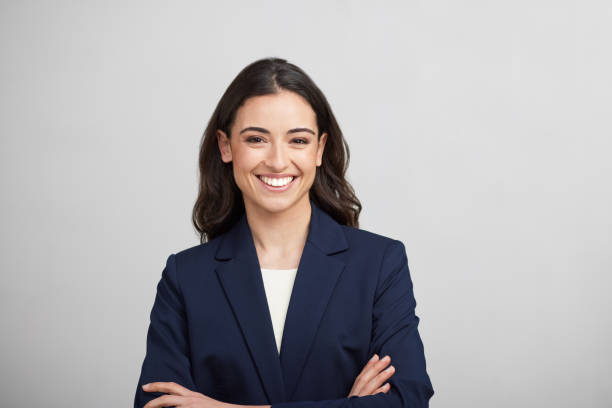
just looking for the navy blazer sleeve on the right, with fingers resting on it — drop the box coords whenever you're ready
[271,240,434,408]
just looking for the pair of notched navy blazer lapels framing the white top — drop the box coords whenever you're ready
[215,199,348,404]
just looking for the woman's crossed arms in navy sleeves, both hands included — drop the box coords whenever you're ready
[134,240,434,408]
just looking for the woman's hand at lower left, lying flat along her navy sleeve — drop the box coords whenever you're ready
[142,382,228,408]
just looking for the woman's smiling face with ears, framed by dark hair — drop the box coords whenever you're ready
[217,90,327,217]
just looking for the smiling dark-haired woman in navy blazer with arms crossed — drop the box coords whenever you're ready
[134,58,433,408]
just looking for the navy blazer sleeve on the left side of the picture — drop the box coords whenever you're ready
[134,254,196,408]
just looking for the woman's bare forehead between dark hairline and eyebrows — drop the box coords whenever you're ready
[236,90,317,129]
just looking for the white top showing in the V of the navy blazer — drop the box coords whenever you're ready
[261,268,297,354]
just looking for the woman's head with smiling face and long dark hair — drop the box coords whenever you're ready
[193,58,361,243]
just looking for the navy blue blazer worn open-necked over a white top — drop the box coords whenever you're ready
[134,200,434,408]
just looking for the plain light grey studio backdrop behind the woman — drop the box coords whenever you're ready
[0,0,612,408]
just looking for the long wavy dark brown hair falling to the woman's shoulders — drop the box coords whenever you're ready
[192,58,361,243]
